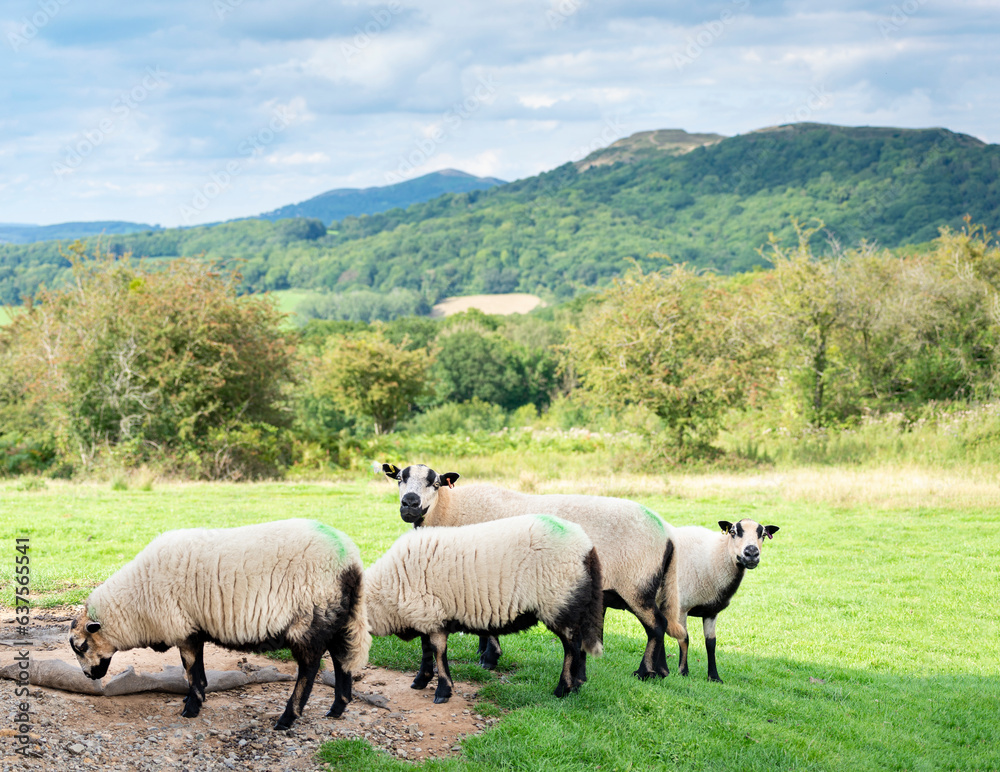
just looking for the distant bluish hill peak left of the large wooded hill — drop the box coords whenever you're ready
[258,169,504,223]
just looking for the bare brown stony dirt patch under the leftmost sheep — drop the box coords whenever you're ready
[0,608,496,772]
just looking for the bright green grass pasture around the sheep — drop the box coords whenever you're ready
[0,459,1000,770]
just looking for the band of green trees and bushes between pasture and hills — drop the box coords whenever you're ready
[0,222,1000,479]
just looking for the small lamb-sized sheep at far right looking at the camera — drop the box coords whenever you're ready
[674,518,779,683]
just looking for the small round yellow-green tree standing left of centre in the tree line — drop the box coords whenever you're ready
[315,330,432,434]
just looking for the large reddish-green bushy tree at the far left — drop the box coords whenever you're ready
[0,249,295,476]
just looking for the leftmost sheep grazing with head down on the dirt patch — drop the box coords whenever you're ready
[69,520,371,729]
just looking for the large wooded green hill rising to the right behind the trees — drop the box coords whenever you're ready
[0,124,1000,305]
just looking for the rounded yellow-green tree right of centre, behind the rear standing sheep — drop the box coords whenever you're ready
[565,265,761,449]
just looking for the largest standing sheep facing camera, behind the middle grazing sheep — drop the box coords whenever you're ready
[382,464,685,679]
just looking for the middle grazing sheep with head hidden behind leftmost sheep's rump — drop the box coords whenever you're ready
[365,515,604,703]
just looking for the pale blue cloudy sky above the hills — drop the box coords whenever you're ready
[0,0,1000,227]
